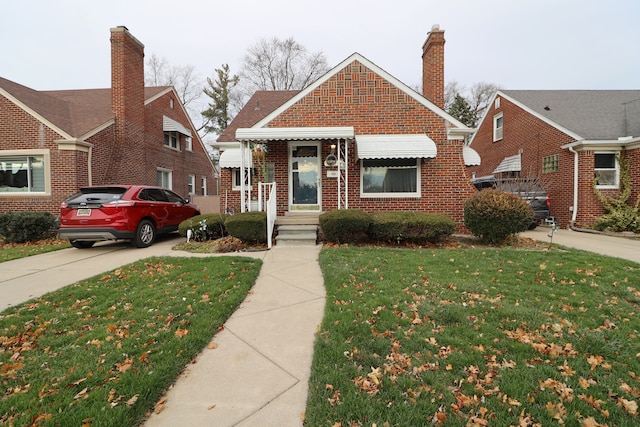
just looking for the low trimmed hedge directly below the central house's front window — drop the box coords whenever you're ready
[369,212,456,243]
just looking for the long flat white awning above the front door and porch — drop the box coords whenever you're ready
[236,126,354,141]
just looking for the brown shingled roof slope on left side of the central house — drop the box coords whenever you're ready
[217,90,300,142]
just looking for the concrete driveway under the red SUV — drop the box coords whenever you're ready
[0,234,190,310]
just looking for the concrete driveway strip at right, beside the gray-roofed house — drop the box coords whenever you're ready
[521,227,640,263]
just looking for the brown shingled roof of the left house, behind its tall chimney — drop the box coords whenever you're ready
[0,77,168,138]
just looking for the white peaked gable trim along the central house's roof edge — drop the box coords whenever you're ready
[252,52,468,129]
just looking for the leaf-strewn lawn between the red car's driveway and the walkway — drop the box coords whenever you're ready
[0,257,262,426]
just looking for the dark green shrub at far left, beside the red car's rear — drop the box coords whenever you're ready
[0,212,56,243]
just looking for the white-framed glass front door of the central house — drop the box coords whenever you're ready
[289,142,322,212]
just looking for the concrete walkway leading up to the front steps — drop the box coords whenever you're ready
[145,245,325,427]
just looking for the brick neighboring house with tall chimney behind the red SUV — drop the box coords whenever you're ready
[0,27,217,214]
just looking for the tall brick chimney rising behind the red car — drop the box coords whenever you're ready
[109,27,144,183]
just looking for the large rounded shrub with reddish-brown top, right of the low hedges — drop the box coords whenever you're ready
[464,189,534,243]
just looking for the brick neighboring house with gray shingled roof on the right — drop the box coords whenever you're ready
[470,90,640,228]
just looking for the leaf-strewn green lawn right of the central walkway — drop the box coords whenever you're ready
[306,248,640,427]
